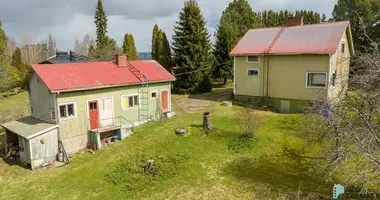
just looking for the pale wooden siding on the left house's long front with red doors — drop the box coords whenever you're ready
[57,82,171,139]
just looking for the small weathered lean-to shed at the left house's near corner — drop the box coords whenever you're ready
[2,116,58,170]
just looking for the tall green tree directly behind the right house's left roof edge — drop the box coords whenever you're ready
[213,0,260,84]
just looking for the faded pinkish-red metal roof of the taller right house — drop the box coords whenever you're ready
[230,21,349,55]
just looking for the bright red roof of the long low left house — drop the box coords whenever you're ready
[32,60,175,91]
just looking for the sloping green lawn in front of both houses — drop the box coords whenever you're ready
[0,88,332,200]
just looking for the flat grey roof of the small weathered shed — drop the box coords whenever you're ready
[2,116,58,139]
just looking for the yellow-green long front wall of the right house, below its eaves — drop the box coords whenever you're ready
[235,55,329,100]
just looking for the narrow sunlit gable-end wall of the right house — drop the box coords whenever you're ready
[330,30,351,100]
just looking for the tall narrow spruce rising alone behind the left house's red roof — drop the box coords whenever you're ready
[95,0,108,49]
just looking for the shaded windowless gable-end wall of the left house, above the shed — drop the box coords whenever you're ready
[29,73,55,123]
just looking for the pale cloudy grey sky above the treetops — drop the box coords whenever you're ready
[0,0,336,51]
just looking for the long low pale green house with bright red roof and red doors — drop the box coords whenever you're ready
[1,55,175,169]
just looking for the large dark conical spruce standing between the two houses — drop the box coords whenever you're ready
[173,0,213,93]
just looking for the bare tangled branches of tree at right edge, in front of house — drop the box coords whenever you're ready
[306,25,380,188]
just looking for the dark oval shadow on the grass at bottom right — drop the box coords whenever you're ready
[223,156,332,194]
